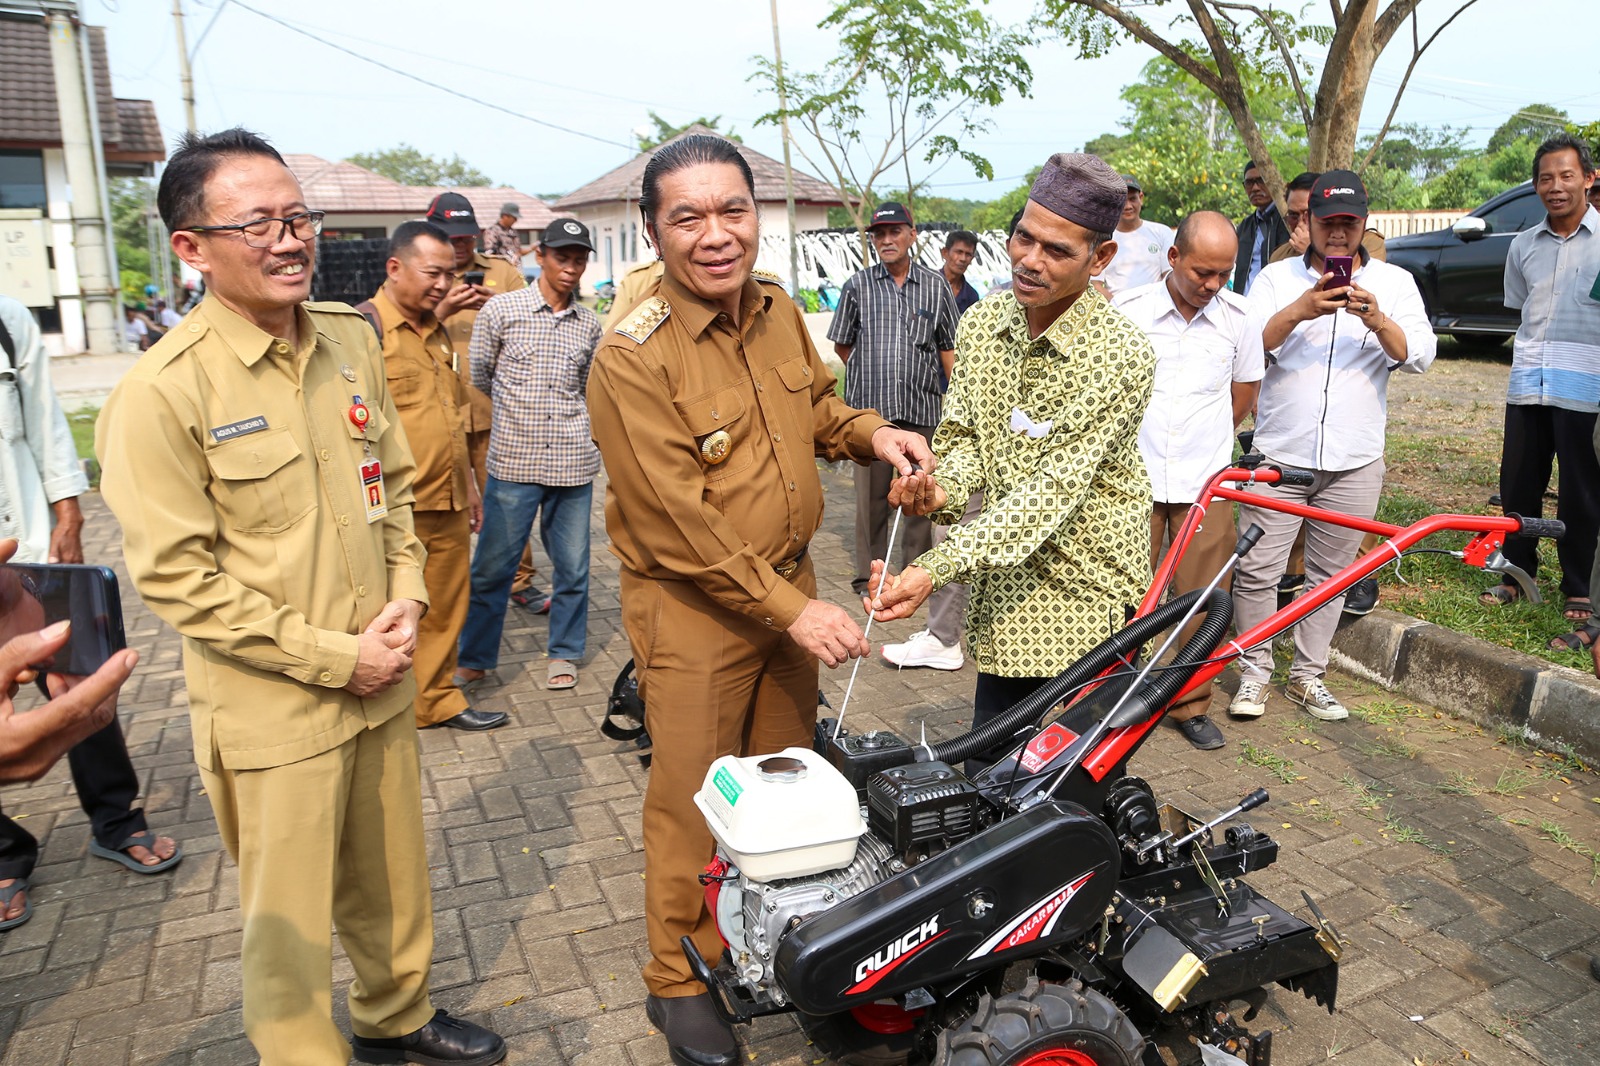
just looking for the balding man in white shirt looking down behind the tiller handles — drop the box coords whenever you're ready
[1115,211,1266,751]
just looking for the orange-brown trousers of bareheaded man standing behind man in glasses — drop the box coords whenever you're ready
[411,509,472,728]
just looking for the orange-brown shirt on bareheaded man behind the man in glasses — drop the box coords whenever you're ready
[373,290,472,511]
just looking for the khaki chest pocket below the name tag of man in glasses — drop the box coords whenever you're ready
[205,427,317,533]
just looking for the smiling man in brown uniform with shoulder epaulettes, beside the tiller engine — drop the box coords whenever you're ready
[589,136,933,1066]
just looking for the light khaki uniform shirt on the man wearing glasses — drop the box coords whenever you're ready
[94,298,427,770]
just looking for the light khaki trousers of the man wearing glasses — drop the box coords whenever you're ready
[200,711,434,1066]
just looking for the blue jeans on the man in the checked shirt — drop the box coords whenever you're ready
[456,477,594,671]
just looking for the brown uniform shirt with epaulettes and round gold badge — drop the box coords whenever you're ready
[589,270,888,631]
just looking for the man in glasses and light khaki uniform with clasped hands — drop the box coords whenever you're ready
[96,130,506,1066]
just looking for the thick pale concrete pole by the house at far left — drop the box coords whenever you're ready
[45,11,122,354]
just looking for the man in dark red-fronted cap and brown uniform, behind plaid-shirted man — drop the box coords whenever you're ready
[426,192,549,601]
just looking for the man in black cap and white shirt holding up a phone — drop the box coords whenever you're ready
[1229,170,1437,722]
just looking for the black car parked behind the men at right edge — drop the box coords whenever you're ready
[1387,182,1546,344]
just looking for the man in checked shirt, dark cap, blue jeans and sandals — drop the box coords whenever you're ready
[456,218,600,688]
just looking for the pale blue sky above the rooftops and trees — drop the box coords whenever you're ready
[82,0,1600,198]
